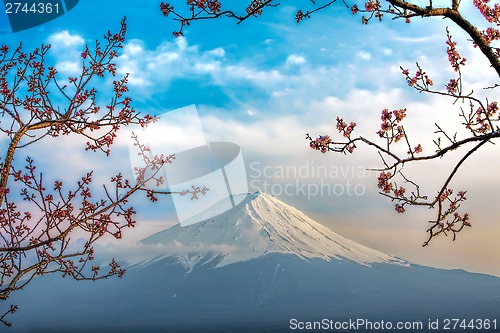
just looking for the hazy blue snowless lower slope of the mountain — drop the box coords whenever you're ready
[11,253,500,333]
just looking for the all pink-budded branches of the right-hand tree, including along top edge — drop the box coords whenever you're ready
[160,0,500,246]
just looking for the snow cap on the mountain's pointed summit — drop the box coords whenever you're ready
[142,192,408,270]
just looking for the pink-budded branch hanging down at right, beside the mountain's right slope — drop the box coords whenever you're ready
[306,23,500,246]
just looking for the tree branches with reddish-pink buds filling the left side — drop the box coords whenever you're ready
[0,19,207,325]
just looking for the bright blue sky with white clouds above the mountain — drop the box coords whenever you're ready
[1,0,500,275]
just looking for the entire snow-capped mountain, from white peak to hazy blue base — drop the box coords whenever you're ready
[8,193,500,332]
